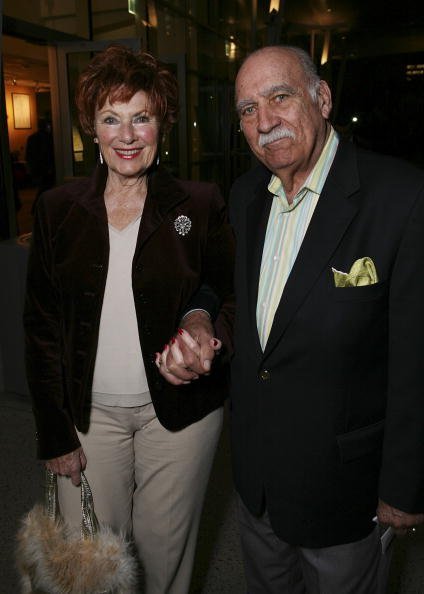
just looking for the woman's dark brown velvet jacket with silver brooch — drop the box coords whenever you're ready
[24,166,234,459]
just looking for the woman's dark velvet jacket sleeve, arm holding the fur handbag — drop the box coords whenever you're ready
[24,197,80,459]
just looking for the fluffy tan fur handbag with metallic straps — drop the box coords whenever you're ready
[17,470,137,594]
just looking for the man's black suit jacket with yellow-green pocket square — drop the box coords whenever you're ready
[230,142,424,547]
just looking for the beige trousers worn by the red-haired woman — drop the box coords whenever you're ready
[58,404,223,594]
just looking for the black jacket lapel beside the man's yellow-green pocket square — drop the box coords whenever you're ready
[264,142,359,356]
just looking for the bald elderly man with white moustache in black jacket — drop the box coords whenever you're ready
[162,46,424,594]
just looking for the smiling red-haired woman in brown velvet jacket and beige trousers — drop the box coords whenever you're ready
[25,46,233,594]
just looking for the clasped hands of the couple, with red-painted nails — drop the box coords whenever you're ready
[155,311,222,386]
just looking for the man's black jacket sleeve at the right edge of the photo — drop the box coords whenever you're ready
[379,184,424,513]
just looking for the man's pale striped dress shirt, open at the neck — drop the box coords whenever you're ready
[256,128,339,350]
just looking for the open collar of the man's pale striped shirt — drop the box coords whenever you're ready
[268,127,339,212]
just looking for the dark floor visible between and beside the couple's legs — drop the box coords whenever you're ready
[0,393,424,594]
